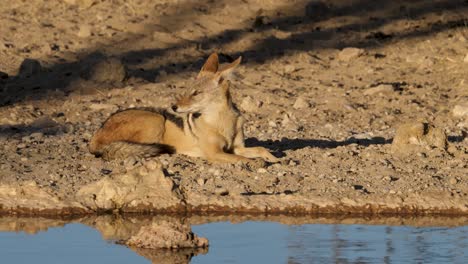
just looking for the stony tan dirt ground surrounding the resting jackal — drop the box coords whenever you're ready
[0,0,468,213]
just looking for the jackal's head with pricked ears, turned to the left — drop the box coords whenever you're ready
[171,53,241,113]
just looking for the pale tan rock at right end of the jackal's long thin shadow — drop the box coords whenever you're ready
[392,123,447,154]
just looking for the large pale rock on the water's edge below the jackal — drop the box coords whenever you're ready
[75,161,182,212]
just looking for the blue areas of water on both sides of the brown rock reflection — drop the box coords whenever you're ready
[0,222,468,264]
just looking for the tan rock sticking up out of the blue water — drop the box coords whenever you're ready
[125,221,208,249]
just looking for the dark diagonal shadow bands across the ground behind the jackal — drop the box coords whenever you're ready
[0,0,468,106]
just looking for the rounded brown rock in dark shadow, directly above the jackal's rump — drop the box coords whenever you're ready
[81,58,127,83]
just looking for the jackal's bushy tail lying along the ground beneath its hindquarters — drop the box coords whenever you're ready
[93,141,175,160]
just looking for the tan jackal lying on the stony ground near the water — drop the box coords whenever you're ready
[89,54,278,163]
